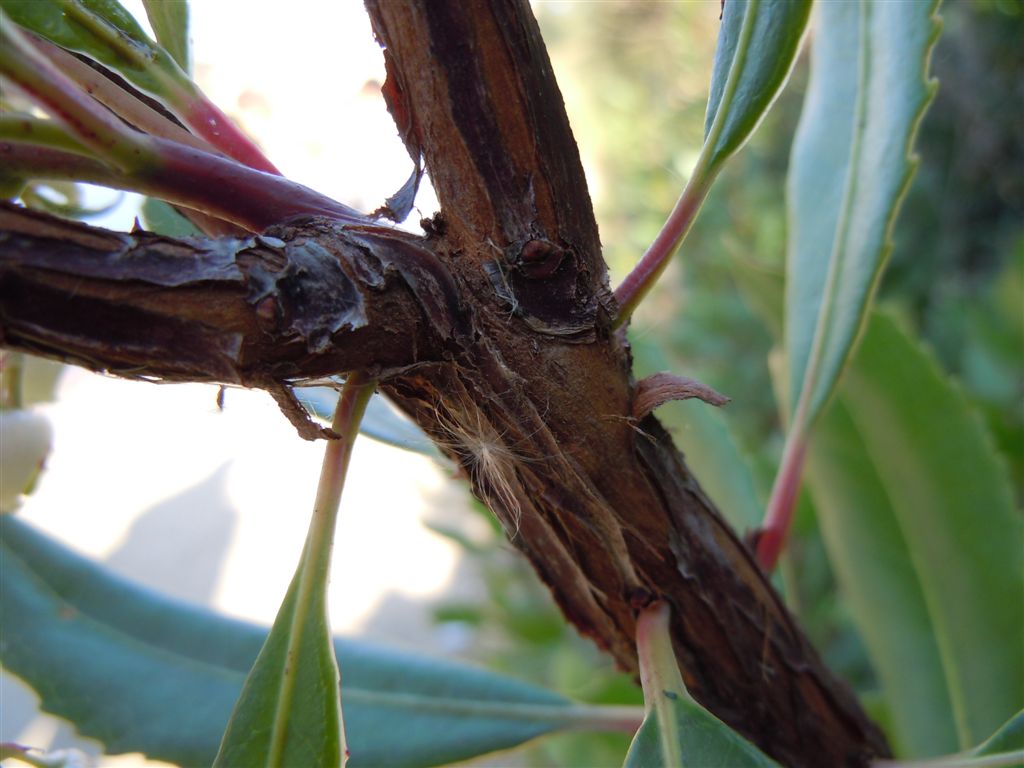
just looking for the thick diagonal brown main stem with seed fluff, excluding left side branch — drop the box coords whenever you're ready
[367,0,888,766]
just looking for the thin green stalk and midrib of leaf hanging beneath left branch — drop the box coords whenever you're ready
[266,374,374,766]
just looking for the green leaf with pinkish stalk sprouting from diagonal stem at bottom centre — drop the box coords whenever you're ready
[625,604,778,768]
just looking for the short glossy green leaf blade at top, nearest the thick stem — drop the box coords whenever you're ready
[701,0,811,174]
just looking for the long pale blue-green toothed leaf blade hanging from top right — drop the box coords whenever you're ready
[786,0,939,430]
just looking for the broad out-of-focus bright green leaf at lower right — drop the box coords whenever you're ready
[807,313,1024,757]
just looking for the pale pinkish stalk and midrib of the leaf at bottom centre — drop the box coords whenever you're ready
[637,602,690,766]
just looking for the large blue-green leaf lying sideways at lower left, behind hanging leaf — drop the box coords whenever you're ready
[0,517,600,768]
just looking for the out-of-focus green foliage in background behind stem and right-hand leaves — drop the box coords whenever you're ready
[437,0,1024,766]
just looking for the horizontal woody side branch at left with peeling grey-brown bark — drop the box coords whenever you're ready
[0,203,454,386]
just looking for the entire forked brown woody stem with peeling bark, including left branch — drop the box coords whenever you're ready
[0,0,888,766]
